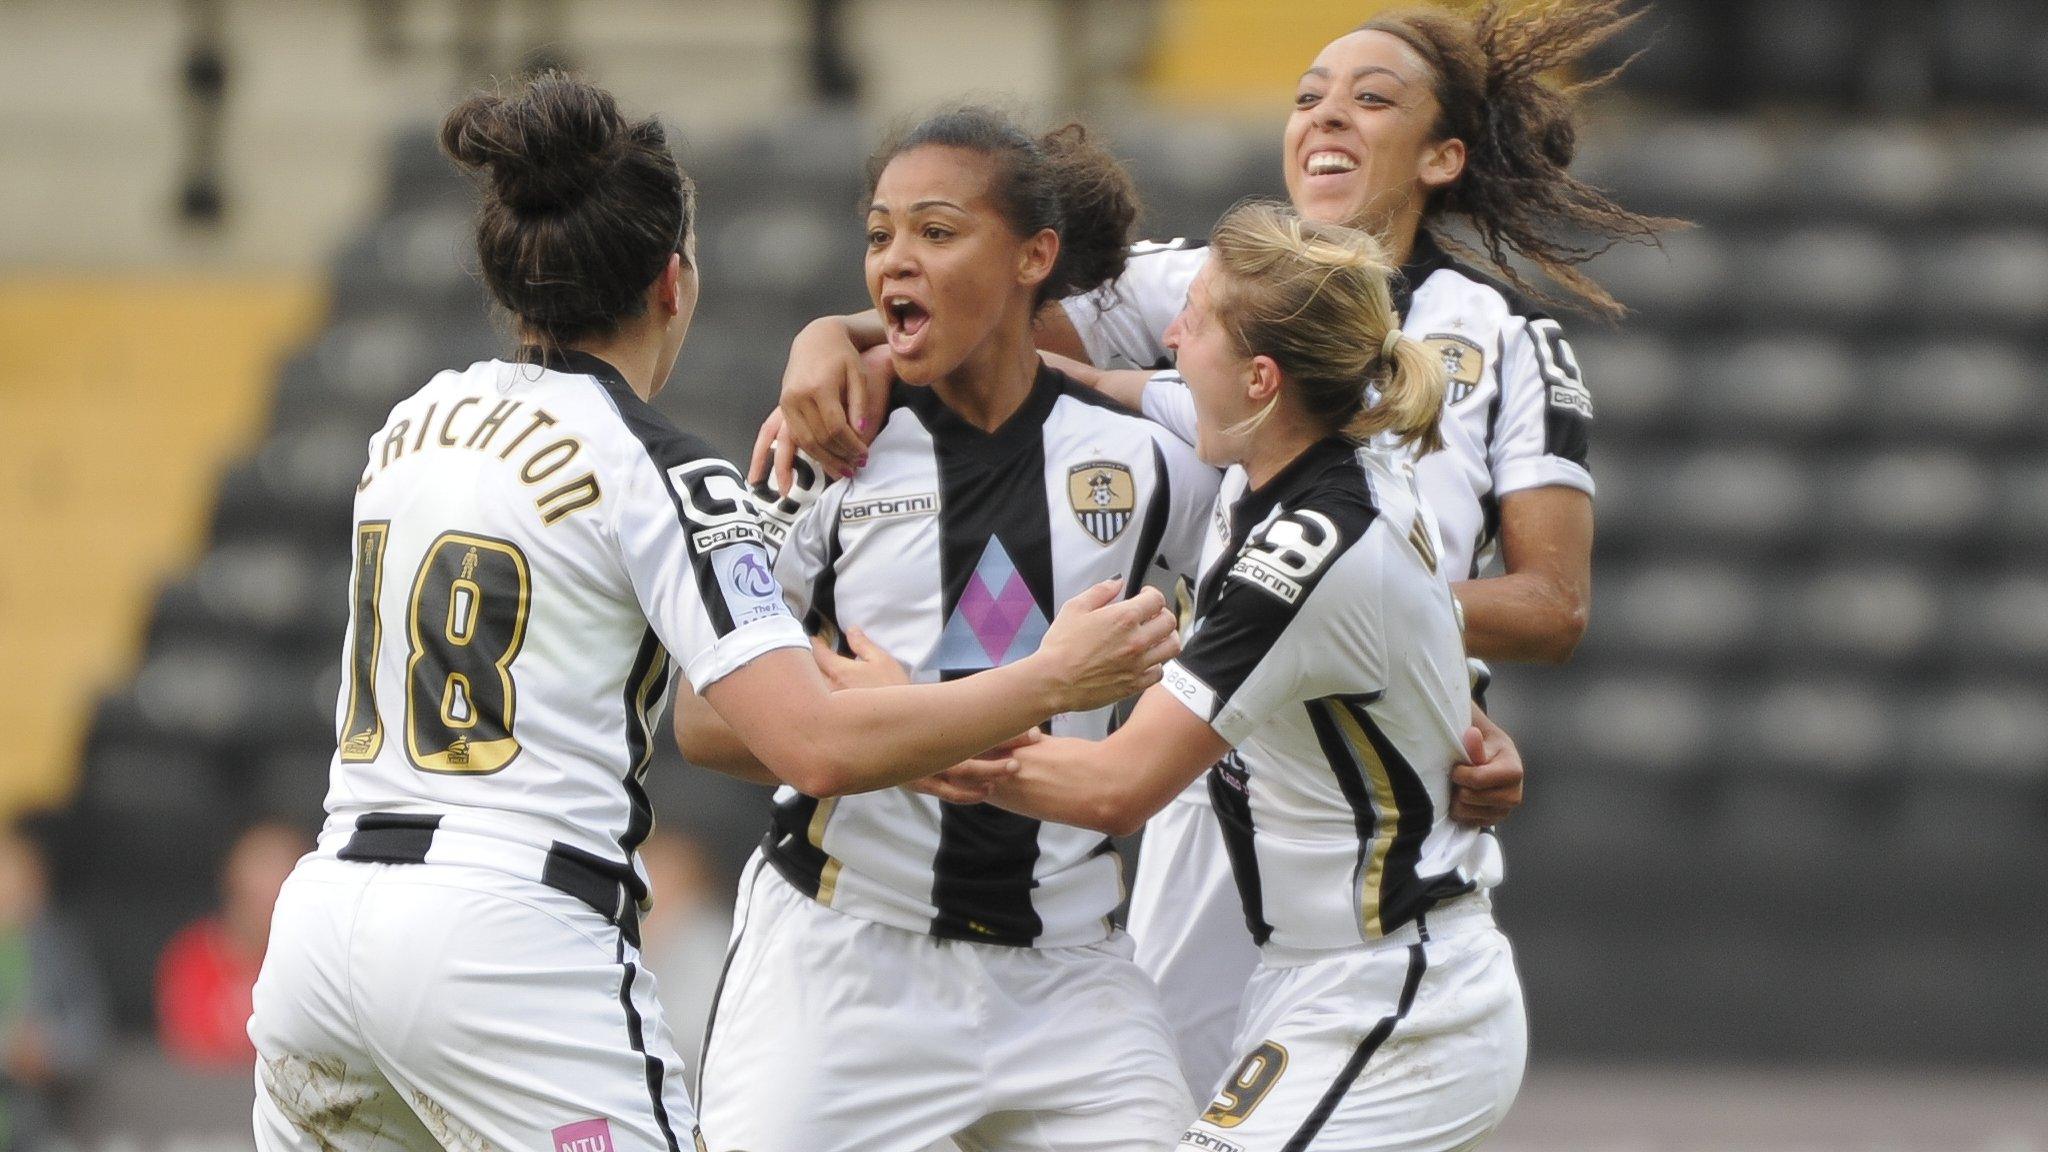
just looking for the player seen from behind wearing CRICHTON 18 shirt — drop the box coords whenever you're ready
[250,74,1178,1152]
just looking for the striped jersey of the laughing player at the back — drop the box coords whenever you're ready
[1065,234,1593,580]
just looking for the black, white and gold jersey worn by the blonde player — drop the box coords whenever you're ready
[1163,439,1501,949]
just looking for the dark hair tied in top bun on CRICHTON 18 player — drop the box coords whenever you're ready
[440,72,690,342]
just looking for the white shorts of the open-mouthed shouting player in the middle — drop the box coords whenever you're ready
[696,855,1196,1152]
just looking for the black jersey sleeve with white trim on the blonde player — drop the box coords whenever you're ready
[1161,498,1384,746]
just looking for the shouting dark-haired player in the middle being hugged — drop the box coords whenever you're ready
[684,109,1219,1152]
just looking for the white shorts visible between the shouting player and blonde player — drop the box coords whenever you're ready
[1130,797,1260,1097]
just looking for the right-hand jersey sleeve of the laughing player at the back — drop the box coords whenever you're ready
[1487,314,1593,496]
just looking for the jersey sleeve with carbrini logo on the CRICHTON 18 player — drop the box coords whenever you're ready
[612,437,809,693]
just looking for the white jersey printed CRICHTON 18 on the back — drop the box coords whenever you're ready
[322,353,809,896]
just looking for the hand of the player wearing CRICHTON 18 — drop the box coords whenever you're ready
[1032,580,1180,711]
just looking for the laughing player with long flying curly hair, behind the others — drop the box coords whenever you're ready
[756,0,1671,1091]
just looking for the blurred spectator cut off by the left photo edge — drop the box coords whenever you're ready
[0,815,106,1152]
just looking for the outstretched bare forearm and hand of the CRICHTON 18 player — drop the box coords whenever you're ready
[684,580,1180,797]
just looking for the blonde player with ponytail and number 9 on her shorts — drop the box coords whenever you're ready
[993,205,1528,1152]
